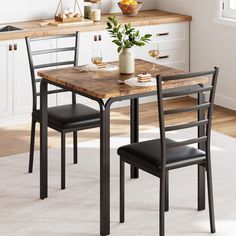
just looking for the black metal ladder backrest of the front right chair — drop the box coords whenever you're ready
[157,67,219,168]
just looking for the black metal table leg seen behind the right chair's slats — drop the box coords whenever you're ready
[198,88,205,211]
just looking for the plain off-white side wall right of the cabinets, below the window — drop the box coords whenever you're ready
[157,0,236,110]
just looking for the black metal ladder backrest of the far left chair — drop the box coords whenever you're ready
[25,32,79,110]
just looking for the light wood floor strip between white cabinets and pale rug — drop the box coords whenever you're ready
[0,98,236,157]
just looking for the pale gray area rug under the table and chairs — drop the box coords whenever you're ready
[0,129,236,236]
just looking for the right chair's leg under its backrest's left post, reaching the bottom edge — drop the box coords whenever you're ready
[159,173,166,236]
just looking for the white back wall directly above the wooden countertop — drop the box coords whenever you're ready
[0,0,156,23]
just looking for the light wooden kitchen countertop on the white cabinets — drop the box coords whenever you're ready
[0,10,192,40]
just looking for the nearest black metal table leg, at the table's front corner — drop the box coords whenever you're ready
[99,101,110,236]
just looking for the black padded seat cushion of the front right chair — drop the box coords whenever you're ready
[118,139,205,171]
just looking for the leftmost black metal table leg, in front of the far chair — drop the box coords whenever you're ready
[40,80,48,199]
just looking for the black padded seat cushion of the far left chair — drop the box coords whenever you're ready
[33,104,100,129]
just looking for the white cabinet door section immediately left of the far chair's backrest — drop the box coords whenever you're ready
[13,39,32,114]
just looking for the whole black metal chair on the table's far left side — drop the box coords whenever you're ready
[25,32,100,189]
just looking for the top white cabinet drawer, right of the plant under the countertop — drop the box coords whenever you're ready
[139,22,189,43]
